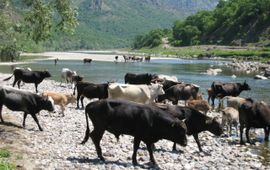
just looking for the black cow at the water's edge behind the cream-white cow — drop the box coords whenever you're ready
[125,73,157,85]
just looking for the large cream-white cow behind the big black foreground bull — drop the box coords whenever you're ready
[108,83,165,104]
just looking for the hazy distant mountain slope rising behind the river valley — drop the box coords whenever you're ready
[44,0,219,50]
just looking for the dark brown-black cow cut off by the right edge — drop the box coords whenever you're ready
[239,98,270,144]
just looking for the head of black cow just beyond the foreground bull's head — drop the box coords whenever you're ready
[205,117,223,136]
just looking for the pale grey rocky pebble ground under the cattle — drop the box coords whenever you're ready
[0,74,269,170]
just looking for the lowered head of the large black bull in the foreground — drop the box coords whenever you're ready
[171,120,187,146]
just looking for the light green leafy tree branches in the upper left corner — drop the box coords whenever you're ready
[0,0,77,61]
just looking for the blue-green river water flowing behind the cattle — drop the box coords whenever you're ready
[0,59,270,165]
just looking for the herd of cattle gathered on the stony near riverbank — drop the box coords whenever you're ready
[0,68,270,165]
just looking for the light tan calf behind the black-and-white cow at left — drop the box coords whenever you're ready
[42,91,76,116]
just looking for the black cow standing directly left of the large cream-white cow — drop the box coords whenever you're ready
[73,81,109,109]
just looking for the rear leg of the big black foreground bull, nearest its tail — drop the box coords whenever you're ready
[90,129,105,161]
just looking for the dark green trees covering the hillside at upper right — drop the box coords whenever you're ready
[133,0,270,48]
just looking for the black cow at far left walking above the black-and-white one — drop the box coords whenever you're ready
[4,69,51,93]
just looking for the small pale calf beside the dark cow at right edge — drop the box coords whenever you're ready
[221,107,239,136]
